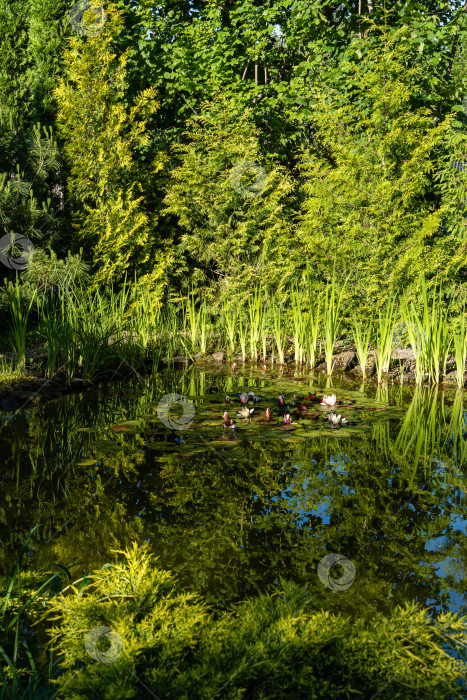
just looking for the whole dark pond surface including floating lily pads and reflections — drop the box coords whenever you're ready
[0,368,467,615]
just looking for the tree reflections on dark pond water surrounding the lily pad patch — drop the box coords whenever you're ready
[0,371,466,612]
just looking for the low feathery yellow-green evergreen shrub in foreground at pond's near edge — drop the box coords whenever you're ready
[47,546,466,700]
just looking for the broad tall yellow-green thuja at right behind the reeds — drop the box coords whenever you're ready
[301,19,465,309]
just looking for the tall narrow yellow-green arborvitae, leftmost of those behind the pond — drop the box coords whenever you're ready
[55,0,170,290]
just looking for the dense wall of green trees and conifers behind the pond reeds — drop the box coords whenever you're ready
[0,0,467,307]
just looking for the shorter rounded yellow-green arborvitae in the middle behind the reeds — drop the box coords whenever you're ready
[165,95,300,294]
